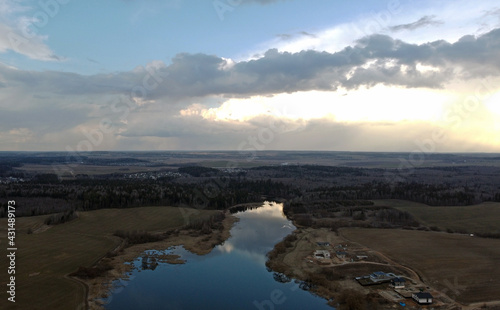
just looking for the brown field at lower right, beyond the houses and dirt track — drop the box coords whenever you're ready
[341,228,500,303]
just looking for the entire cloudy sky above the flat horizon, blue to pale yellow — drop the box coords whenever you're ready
[0,0,500,153]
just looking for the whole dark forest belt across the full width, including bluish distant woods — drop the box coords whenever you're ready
[0,159,500,217]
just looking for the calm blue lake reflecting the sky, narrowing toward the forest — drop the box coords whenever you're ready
[106,203,333,310]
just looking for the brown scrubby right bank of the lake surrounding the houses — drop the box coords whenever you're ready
[266,226,500,310]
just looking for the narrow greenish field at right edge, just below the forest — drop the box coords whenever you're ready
[374,199,500,233]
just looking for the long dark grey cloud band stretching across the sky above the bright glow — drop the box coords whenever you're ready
[0,29,500,101]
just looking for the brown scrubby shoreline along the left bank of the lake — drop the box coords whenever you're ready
[79,212,239,310]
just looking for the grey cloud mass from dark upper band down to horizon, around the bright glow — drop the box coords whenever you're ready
[0,27,500,151]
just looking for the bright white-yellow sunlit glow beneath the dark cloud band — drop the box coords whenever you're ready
[199,85,448,122]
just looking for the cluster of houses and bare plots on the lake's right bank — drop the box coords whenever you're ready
[296,229,454,309]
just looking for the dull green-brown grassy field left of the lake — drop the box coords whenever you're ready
[0,207,219,310]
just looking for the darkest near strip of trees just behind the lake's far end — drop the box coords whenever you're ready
[0,163,494,217]
